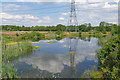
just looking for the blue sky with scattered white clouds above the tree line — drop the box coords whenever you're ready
[0,0,119,26]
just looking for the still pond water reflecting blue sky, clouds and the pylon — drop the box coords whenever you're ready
[12,38,100,78]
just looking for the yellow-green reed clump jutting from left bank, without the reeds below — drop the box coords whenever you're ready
[2,42,33,60]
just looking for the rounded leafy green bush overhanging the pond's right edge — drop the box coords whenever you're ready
[98,35,120,79]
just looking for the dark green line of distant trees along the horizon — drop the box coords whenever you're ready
[0,21,117,32]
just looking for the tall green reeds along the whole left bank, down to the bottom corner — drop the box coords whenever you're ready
[2,41,34,78]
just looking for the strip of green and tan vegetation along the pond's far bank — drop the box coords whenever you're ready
[2,31,111,45]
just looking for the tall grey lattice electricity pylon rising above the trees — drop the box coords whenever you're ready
[67,0,78,32]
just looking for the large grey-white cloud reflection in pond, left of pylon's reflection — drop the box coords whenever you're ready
[19,54,64,73]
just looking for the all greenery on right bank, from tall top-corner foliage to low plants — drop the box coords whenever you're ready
[91,26,120,80]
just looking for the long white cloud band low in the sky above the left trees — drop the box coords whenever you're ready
[0,13,51,26]
